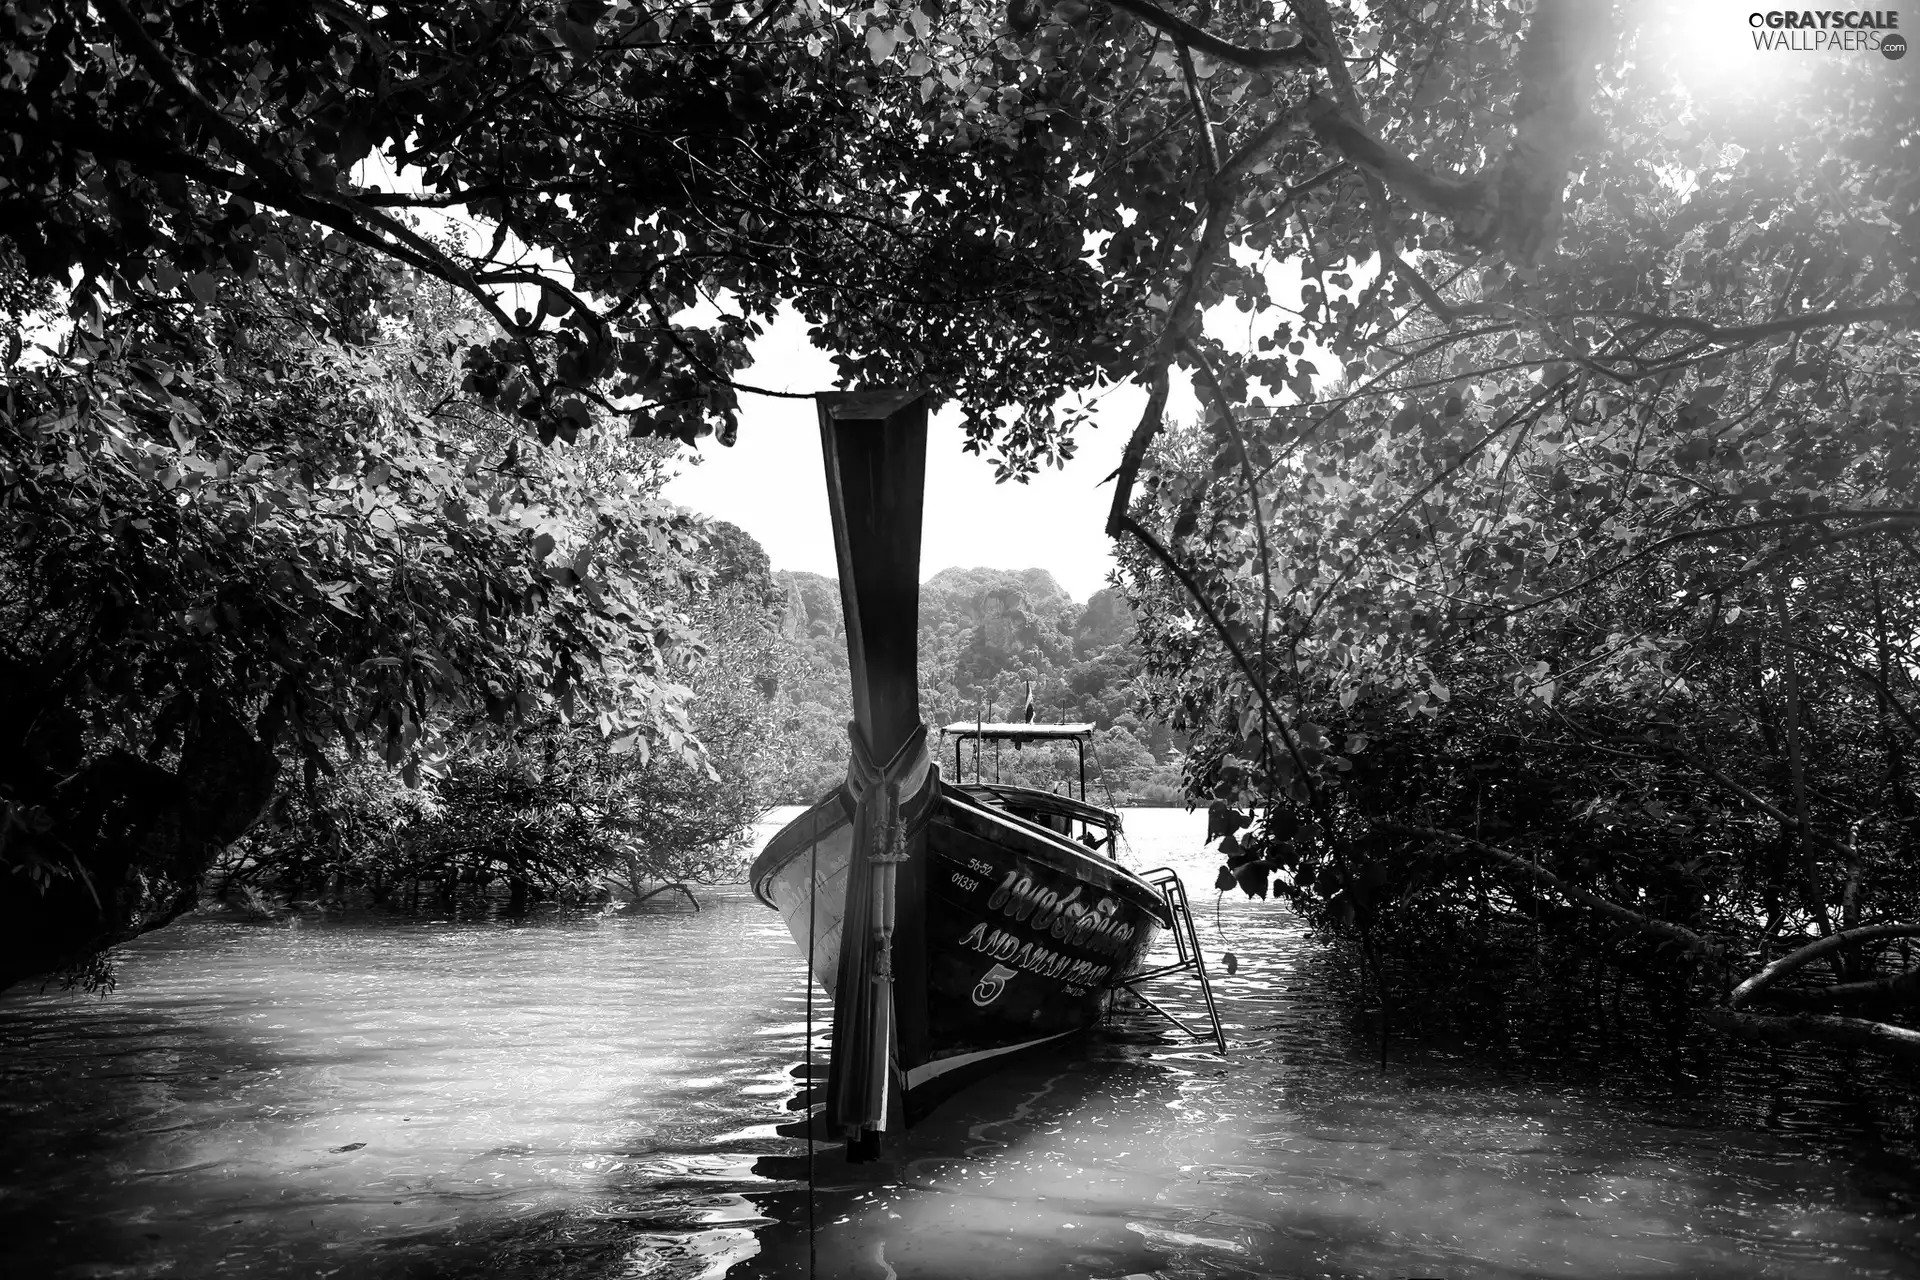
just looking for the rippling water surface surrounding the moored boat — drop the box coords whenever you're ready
[0,810,1920,1280]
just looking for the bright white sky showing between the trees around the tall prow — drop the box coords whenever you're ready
[666,313,1196,601]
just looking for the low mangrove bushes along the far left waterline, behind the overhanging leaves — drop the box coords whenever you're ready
[217,560,793,915]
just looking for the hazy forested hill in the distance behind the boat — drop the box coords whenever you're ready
[774,568,1179,804]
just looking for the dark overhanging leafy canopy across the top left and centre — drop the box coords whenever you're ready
[0,0,1119,458]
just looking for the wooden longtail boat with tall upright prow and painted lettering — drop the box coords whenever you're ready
[751,391,1171,1159]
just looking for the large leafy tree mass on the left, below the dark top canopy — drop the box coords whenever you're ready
[0,257,718,979]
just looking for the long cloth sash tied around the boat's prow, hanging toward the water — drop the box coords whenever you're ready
[826,723,939,1146]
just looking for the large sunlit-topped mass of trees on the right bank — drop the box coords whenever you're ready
[1098,10,1920,1054]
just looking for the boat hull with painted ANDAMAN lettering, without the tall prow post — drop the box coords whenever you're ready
[751,783,1165,1121]
